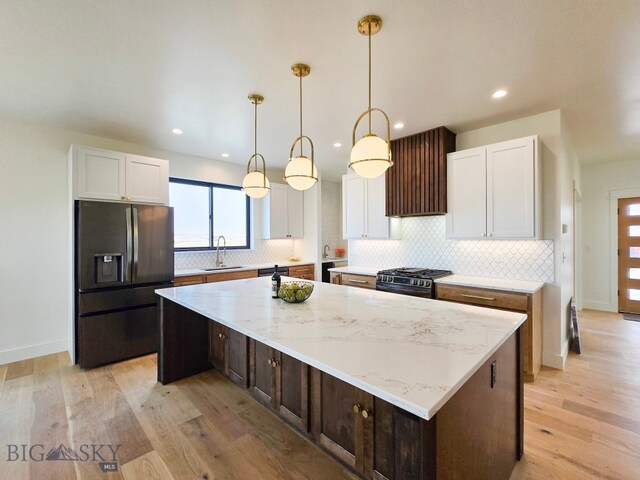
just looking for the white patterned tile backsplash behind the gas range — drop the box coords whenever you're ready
[348,215,554,282]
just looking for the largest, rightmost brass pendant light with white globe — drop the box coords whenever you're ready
[349,15,393,178]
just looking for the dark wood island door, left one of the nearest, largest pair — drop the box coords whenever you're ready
[311,368,373,470]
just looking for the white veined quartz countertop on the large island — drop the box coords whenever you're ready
[156,277,526,420]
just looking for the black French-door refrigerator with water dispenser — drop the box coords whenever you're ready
[74,201,174,368]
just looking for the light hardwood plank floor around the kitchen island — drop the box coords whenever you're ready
[0,310,640,480]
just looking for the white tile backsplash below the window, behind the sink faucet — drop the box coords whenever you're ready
[175,239,294,270]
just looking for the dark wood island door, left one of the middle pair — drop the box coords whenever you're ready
[249,339,278,408]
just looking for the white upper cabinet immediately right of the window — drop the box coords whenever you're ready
[262,183,304,239]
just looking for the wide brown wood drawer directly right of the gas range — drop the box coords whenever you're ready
[436,284,528,312]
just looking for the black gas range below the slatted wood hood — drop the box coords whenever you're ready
[376,268,453,298]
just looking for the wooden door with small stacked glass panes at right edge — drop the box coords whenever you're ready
[618,198,640,313]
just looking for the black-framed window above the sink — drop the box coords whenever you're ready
[169,178,250,250]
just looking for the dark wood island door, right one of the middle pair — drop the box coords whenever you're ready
[275,352,309,432]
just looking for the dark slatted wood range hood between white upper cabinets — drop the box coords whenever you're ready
[385,127,456,217]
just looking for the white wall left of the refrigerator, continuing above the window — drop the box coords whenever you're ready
[0,119,286,364]
